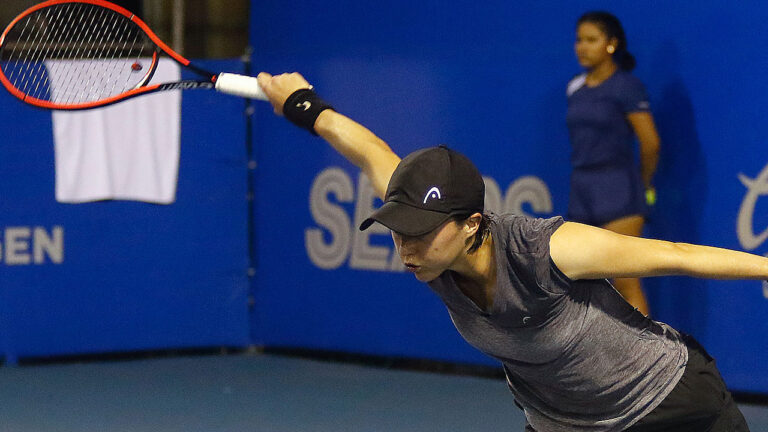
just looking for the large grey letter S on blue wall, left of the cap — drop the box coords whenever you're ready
[304,168,354,269]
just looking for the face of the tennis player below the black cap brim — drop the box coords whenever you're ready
[392,220,472,282]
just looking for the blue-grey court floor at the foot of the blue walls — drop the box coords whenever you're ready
[0,354,768,432]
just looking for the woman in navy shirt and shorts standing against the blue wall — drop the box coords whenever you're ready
[566,12,659,315]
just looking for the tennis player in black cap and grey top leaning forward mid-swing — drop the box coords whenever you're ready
[258,73,752,432]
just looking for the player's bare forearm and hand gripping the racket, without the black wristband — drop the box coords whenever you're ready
[258,72,400,199]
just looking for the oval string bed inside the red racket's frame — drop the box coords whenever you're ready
[0,3,155,105]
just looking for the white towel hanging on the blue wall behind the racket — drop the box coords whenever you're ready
[48,59,181,204]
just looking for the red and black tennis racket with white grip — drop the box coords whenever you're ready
[0,0,267,110]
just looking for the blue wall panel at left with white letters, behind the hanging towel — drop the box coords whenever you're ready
[0,57,248,362]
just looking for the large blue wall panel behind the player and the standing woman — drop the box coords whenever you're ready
[251,0,768,392]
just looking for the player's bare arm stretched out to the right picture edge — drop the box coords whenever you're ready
[549,222,768,280]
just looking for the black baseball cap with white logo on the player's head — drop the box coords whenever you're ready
[360,145,485,236]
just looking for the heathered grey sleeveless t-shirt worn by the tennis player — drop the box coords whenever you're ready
[429,215,688,432]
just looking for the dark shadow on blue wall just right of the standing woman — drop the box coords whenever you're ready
[644,41,709,339]
